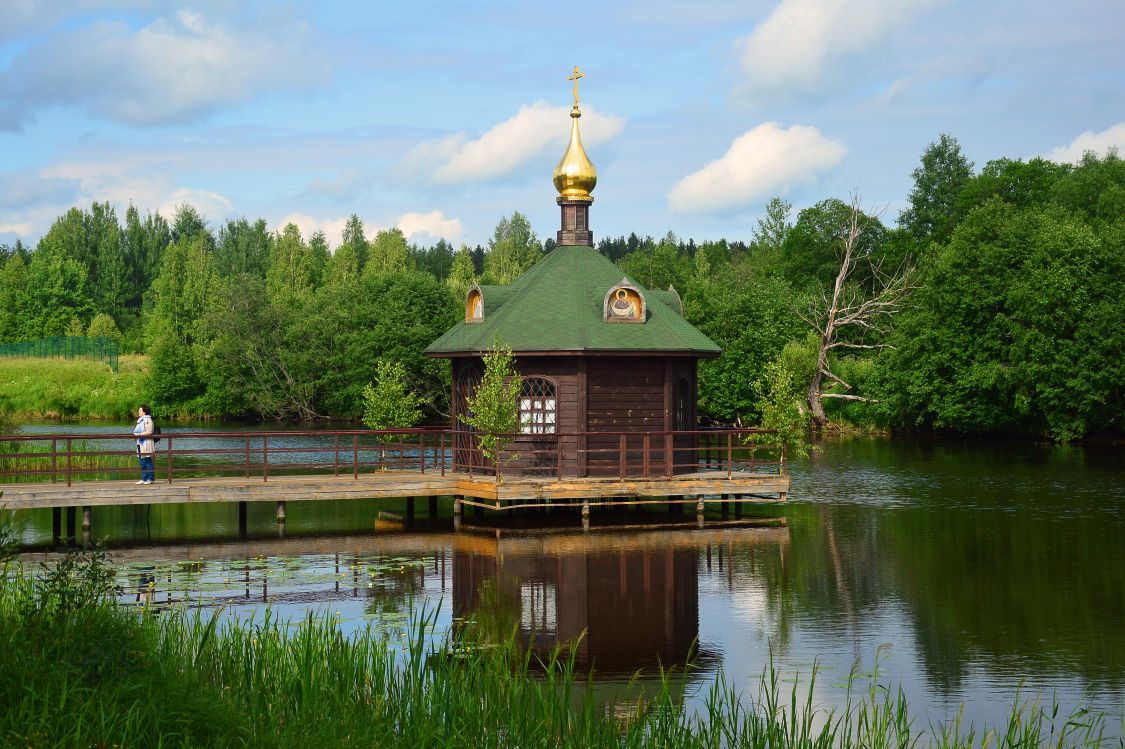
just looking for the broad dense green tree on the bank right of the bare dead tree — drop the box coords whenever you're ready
[879,199,1125,440]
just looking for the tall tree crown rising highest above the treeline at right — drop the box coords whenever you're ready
[899,133,973,247]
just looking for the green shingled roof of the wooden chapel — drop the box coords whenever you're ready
[426,240,721,357]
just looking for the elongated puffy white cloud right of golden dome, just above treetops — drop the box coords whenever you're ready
[668,123,847,214]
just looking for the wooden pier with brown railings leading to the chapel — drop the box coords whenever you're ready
[0,430,790,539]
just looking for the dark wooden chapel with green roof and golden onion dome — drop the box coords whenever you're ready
[426,69,720,477]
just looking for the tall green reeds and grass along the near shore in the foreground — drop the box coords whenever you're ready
[0,537,1125,749]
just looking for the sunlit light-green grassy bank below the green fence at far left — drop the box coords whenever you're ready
[0,355,147,422]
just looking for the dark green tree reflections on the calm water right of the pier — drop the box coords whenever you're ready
[769,494,1125,695]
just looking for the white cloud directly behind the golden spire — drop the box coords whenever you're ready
[403,101,626,184]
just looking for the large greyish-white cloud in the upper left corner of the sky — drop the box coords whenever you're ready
[0,10,330,129]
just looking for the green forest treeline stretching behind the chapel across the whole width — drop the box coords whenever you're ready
[0,135,1125,440]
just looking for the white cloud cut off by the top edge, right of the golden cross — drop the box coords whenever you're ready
[736,0,941,96]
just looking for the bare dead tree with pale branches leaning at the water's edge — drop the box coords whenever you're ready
[798,192,916,428]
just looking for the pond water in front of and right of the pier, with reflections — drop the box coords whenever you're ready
[8,427,1125,734]
